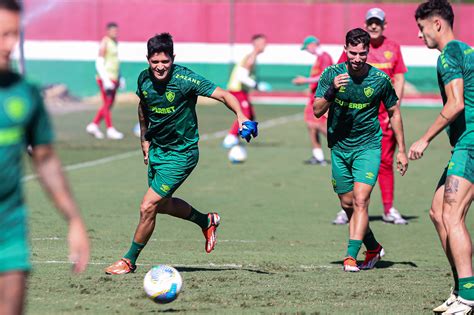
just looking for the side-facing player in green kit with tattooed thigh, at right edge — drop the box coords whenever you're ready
[408,0,474,314]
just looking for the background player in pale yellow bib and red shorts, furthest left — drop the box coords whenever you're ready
[86,22,123,140]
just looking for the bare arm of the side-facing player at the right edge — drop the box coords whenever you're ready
[408,78,464,160]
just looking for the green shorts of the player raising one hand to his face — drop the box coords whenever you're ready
[331,149,381,194]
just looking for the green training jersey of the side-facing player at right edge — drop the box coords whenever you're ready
[437,40,474,150]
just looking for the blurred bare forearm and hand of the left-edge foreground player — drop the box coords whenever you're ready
[32,144,90,272]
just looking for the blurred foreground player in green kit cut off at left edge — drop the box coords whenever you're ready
[0,0,89,315]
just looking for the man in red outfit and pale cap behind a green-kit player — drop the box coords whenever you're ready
[333,8,408,224]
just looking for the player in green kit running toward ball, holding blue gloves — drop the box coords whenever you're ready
[105,33,257,275]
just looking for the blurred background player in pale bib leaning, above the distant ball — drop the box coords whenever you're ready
[222,34,271,149]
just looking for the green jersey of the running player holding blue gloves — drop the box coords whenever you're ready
[136,64,216,151]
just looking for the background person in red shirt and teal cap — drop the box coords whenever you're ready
[292,36,333,165]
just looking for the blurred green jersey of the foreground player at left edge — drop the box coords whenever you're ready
[0,72,53,227]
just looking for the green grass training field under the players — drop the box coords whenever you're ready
[26,105,474,314]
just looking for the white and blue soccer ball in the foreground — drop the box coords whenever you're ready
[143,265,183,304]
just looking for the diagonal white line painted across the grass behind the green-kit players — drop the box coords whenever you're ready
[22,113,303,182]
